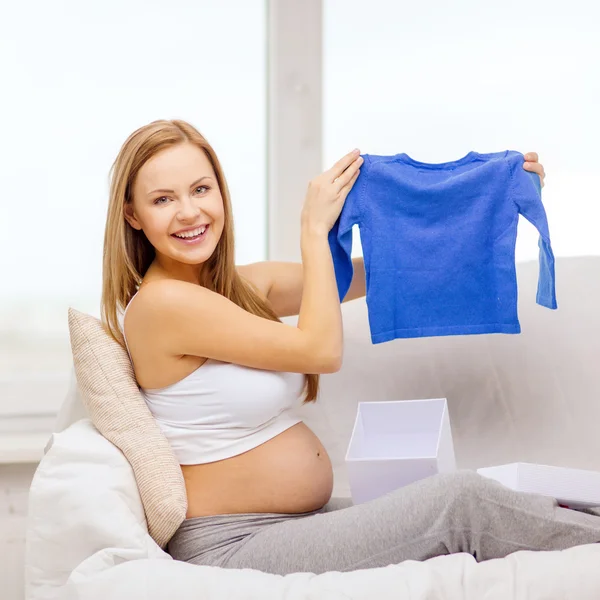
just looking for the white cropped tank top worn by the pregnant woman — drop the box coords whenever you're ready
[121,294,305,465]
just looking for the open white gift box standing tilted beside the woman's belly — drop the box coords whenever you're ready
[346,398,456,504]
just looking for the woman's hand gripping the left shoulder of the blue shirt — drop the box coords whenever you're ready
[302,149,363,234]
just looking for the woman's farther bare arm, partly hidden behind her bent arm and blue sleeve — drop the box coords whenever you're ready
[238,256,366,317]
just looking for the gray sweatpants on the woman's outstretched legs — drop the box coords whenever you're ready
[168,471,600,575]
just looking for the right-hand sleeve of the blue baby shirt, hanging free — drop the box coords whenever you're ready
[509,154,557,309]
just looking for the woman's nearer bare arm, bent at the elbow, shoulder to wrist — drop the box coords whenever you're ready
[136,236,342,373]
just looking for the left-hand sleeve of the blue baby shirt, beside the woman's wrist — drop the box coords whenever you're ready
[329,154,369,302]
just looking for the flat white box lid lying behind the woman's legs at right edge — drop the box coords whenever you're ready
[477,462,600,508]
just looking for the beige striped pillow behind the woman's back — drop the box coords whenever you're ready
[69,308,187,548]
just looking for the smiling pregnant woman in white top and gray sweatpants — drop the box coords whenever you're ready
[102,121,600,575]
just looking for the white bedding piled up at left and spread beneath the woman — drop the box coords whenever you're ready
[26,419,600,600]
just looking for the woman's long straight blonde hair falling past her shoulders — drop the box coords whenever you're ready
[101,120,319,403]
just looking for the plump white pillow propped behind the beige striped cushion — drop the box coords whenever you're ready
[25,419,173,598]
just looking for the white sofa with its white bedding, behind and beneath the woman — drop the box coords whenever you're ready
[26,257,600,600]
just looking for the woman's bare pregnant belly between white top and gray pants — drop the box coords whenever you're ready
[181,423,333,519]
